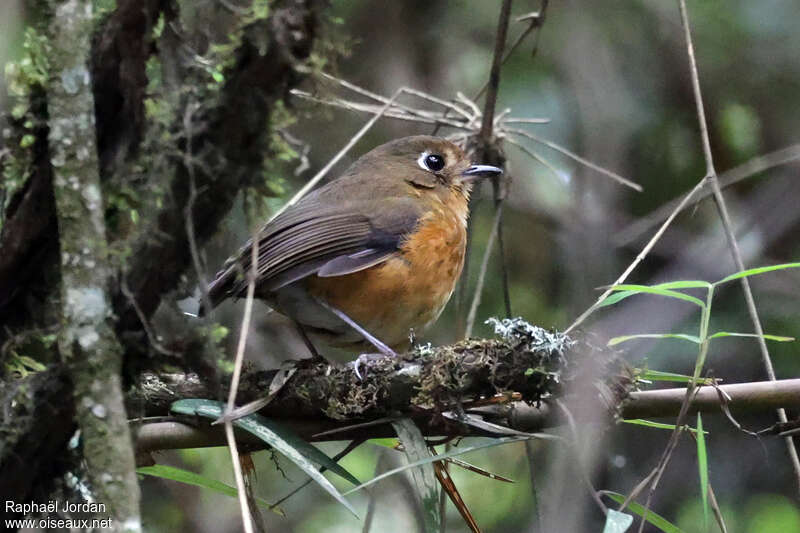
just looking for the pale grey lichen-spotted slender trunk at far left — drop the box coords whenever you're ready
[48,0,141,531]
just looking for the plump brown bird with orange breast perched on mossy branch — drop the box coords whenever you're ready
[201,135,503,366]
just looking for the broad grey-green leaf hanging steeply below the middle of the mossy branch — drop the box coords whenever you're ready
[392,418,442,532]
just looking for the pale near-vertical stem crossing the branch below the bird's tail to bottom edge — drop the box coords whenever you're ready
[225,228,259,533]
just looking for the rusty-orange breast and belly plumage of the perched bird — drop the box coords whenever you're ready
[307,205,467,349]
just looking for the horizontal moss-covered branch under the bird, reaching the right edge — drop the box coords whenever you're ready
[128,324,800,454]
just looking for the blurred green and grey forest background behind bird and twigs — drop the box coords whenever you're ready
[6,0,800,533]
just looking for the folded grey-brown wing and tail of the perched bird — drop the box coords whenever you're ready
[203,198,420,305]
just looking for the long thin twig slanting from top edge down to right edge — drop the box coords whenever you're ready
[679,0,800,493]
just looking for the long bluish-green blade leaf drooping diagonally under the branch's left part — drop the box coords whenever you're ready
[171,399,358,516]
